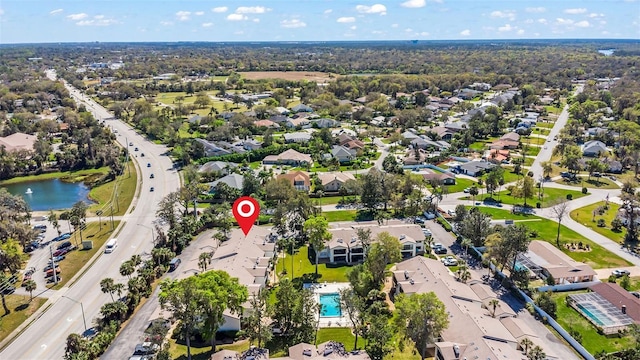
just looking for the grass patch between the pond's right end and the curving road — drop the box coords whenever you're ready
[89,162,137,216]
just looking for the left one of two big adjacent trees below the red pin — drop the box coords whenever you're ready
[158,276,203,360]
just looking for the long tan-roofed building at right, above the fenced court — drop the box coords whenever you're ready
[524,240,596,284]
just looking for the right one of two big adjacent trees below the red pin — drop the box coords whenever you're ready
[195,270,247,353]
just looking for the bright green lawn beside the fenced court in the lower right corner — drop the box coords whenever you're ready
[551,291,633,354]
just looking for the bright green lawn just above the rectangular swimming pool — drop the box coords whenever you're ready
[276,246,350,282]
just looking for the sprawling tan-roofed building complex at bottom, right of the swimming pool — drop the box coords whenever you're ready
[391,256,557,360]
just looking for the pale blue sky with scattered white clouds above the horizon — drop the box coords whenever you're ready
[0,0,640,44]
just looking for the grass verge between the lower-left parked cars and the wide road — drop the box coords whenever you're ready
[52,217,120,290]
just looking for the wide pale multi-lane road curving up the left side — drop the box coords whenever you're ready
[0,73,180,360]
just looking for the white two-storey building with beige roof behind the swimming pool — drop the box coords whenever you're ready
[318,220,425,264]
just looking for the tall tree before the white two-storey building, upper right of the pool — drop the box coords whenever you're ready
[365,231,402,289]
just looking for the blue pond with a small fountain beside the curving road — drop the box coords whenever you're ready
[0,179,91,211]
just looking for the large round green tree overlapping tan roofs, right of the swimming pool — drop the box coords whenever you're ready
[393,292,449,359]
